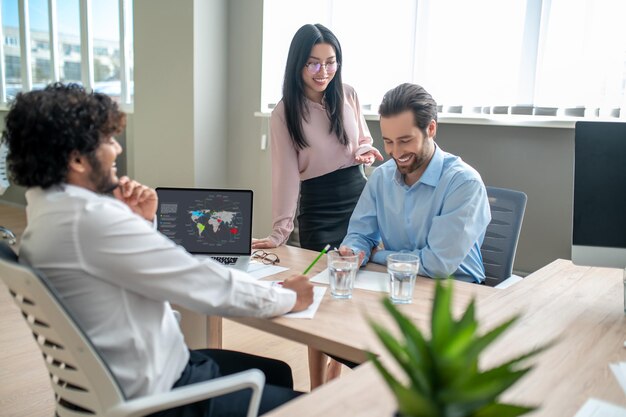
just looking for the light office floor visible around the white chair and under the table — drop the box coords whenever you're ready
[0,204,336,417]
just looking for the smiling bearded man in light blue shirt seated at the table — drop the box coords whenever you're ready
[341,84,491,283]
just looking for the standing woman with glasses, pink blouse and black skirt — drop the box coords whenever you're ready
[252,24,383,251]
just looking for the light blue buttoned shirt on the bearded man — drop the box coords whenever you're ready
[342,146,491,282]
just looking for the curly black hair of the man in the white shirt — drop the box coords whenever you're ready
[2,83,126,188]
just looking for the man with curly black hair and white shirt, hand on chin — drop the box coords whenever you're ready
[2,83,313,416]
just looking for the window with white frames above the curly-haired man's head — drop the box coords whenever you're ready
[0,0,133,110]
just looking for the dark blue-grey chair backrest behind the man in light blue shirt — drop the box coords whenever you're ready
[480,187,528,286]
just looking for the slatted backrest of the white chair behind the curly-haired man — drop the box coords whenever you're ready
[0,242,126,417]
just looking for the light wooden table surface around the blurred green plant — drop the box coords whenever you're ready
[222,247,626,417]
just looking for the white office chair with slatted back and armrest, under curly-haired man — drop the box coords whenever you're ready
[0,242,265,417]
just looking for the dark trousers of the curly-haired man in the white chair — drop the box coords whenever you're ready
[152,349,301,417]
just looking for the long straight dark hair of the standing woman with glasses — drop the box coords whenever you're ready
[283,23,348,149]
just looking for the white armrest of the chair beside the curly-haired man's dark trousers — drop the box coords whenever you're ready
[106,369,265,417]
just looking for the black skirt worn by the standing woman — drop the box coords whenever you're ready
[298,165,367,252]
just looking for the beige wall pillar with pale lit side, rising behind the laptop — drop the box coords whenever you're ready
[129,0,227,187]
